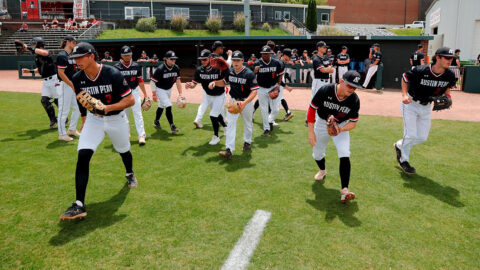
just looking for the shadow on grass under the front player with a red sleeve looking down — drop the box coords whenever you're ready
[307,181,362,227]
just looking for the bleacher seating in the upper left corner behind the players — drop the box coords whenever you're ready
[0,27,102,55]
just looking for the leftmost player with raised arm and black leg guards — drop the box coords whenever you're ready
[22,37,58,129]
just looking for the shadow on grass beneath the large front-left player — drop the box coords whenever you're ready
[50,185,130,246]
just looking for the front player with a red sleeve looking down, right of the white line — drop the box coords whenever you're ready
[308,70,362,203]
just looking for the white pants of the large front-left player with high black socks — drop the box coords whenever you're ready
[77,111,130,153]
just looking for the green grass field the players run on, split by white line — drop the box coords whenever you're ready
[0,92,480,269]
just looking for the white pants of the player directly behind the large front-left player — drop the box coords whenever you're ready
[57,81,80,136]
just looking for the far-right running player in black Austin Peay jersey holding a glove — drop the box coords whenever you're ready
[394,47,456,174]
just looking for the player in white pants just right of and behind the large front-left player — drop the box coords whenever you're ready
[114,46,148,146]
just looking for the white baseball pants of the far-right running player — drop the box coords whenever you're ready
[396,101,432,162]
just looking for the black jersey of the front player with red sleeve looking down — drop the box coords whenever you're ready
[310,83,360,123]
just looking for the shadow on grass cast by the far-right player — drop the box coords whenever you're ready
[397,170,465,207]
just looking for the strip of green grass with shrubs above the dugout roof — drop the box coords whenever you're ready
[97,28,288,39]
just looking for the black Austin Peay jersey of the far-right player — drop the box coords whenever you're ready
[403,65,457,104]
